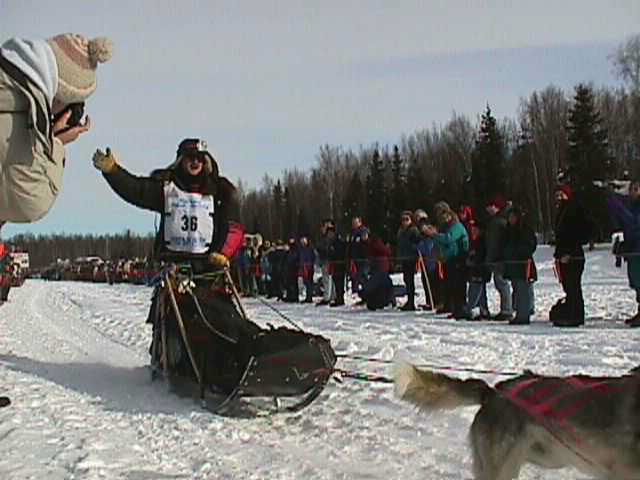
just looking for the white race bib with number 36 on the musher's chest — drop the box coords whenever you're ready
[164,182,214,253]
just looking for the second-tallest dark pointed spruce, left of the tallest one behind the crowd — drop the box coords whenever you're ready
[471,105,507,206]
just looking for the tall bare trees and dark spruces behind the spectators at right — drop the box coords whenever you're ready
[238,35,640,241]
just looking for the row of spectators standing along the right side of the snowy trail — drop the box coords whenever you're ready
[226,182,640,327]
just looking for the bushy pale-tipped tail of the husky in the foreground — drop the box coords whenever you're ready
[394,361,493,410]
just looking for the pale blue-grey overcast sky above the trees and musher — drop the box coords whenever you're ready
[0,0,640,238]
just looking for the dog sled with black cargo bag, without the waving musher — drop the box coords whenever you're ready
[148,265,336,413]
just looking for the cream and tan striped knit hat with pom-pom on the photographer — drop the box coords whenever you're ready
[47,33,113,104]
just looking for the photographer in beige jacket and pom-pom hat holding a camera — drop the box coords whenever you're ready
[0,34,113,227]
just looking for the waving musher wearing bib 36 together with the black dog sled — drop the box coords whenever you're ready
[93,138,335,406]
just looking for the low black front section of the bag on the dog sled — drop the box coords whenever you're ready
[239,327,336,397]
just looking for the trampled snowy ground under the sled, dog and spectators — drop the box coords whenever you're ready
[0,245,640,480]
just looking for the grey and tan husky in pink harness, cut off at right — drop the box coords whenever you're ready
[394,363,640,480]
